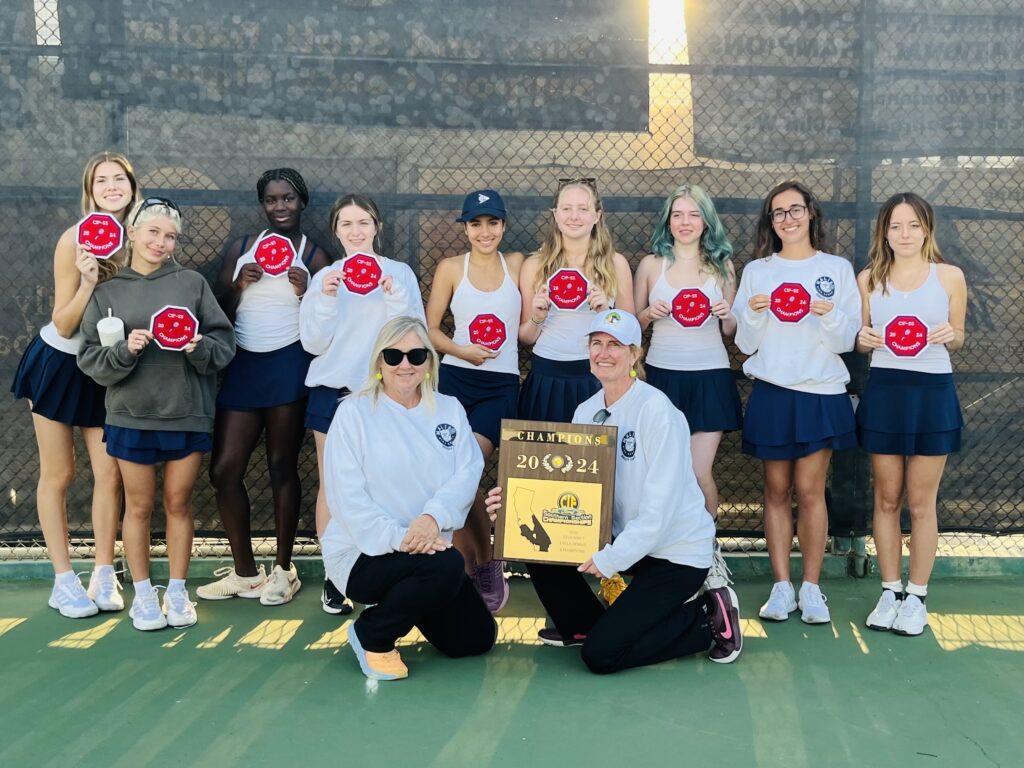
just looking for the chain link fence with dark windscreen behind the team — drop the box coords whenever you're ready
[0,0,1024,555]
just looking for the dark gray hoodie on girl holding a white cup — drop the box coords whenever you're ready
[78,261,234,432]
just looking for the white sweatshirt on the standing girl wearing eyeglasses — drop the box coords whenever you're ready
[732,251,860,394]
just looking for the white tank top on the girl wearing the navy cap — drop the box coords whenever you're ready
[441,253,522,376]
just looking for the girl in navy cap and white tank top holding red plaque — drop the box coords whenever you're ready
[427,189,522,613]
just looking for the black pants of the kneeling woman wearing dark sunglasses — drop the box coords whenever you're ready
[347,549,498,657]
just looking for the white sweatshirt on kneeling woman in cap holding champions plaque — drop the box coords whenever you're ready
[572,380,715,577]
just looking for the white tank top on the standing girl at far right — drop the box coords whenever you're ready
[868,264,953,374]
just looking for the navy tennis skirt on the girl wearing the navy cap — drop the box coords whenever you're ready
[437,365,519,447]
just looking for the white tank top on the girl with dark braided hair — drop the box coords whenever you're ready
[231,229,309,352]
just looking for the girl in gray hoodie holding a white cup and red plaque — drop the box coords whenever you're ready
[78,198,234,630]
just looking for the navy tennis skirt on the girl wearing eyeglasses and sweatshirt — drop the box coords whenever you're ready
[743,379,857,461]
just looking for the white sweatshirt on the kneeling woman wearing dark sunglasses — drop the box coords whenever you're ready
[321,393,483,592]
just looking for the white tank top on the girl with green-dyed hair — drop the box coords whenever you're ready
[647,258,729,371]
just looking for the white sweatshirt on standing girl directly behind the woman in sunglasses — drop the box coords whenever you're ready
[299,256,427,391]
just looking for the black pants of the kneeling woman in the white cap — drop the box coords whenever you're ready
[529,557,712,675]
